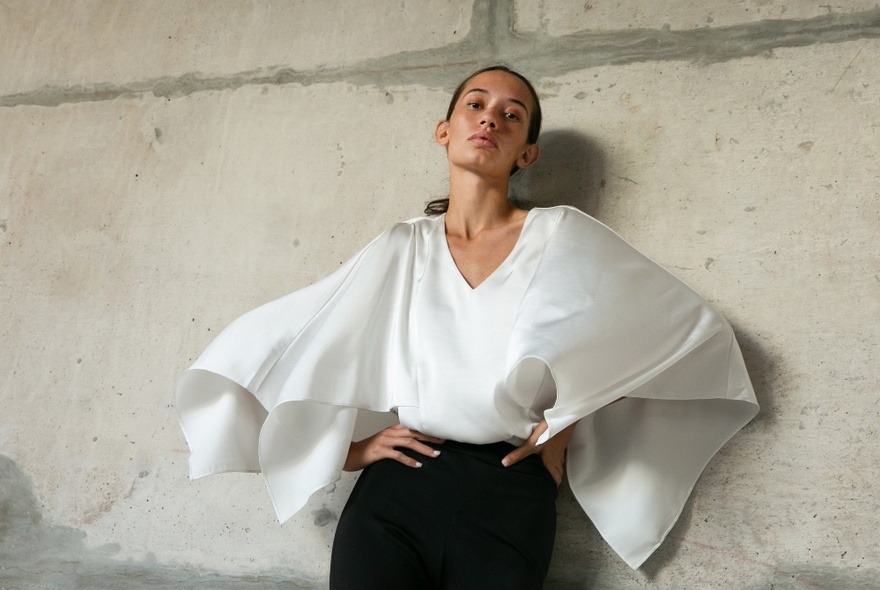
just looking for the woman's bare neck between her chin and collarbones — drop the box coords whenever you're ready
[446,168,525,239]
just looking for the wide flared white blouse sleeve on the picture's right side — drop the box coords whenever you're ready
[508,208,758,568]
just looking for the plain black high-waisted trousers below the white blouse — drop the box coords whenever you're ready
[330,441,557,590]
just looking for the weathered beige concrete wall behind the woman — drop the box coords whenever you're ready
[0,0,880,590]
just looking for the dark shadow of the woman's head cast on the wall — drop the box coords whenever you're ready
[510,130,605,217]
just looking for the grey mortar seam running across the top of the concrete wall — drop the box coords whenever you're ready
[0,0,880,107]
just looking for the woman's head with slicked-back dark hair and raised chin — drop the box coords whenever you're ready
[435,71,539,179]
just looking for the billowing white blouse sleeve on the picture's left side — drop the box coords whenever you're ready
[175,223,421,522]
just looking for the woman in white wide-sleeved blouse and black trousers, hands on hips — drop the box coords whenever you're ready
[177,67,757,590]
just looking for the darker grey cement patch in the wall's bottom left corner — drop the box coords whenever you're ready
[0,455,325,590]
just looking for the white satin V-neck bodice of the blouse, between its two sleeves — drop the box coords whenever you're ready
[398,209,556,445]
